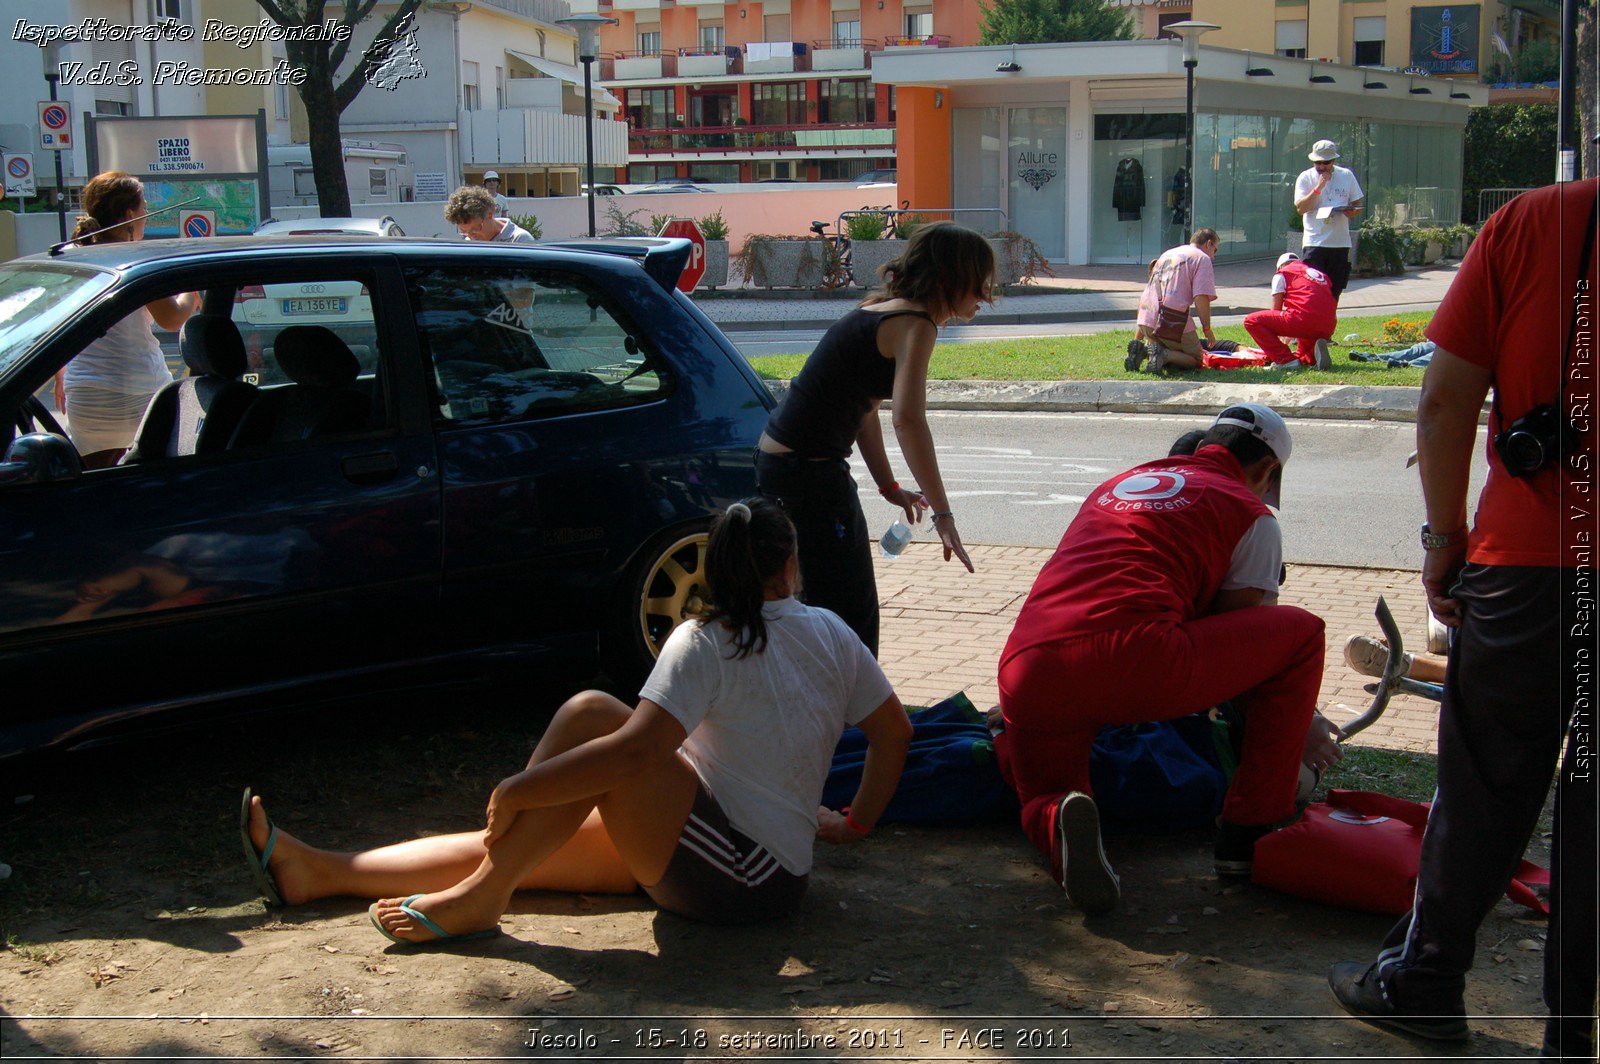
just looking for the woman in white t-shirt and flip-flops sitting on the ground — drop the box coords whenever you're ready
[240,499,910,942]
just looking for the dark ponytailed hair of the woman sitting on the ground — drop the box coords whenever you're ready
[706,498,795,659]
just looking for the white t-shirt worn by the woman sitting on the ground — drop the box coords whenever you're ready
[640,598,894,875]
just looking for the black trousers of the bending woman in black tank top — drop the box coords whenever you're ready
[755,450,878,658]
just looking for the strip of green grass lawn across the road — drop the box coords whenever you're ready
[750,312,1432,387]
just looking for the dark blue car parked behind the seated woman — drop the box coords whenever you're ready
[0,237,773,757]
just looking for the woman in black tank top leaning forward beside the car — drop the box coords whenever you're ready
[755,222,995,656]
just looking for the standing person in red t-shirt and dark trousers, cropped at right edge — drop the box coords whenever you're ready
[1328,181,1600,1061]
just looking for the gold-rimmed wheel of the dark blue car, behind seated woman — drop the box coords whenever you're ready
[602,528,710,698]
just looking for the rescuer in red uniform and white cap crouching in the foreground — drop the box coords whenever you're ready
[995,403,1323,912]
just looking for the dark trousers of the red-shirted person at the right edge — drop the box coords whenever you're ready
[1379,565,1597,1035]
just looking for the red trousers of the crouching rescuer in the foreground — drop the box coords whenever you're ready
[995,606,1323,874]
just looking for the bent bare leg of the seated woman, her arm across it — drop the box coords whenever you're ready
[376,691,696,942]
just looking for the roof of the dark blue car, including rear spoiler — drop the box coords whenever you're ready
[25,234,690,288]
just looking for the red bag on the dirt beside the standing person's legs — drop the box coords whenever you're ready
[1251,789,1550,917]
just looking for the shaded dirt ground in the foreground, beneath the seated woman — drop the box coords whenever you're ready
[0,681,1544,1059]
